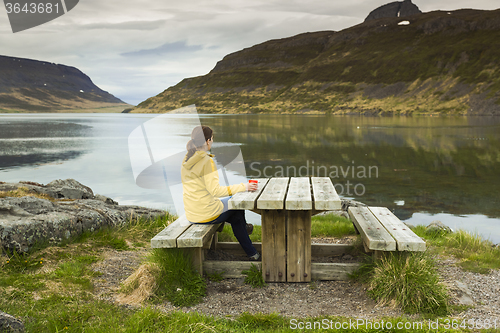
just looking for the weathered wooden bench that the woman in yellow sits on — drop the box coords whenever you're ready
[151,215,224,274]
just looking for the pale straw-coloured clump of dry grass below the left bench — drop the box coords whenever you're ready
[117,263,160,305]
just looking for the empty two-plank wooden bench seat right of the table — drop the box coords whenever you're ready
[348,207,425,258]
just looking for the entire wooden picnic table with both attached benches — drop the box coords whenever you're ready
[151,177,426,282]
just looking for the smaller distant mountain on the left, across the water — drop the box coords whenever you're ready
[0,56,129,112]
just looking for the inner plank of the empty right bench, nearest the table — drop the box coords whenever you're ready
[348,207,396,251]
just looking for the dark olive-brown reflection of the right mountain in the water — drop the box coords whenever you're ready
[202,115,500,217]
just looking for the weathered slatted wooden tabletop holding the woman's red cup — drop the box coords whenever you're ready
[228,177,342,212]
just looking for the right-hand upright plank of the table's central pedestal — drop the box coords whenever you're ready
[286,210,311,282]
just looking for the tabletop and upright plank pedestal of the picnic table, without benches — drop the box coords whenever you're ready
[228,177,341,282]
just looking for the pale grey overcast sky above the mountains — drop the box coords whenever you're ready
[0,0,500,105]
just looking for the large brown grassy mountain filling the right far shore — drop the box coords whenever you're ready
[132,9,500,115]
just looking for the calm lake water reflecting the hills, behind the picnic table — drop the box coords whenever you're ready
[0,114,500,243]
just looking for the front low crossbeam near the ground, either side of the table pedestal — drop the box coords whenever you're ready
[203,260,360,281]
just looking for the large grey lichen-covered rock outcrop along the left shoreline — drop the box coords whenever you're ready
[0,179,166,252]
